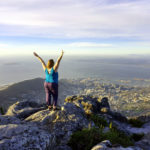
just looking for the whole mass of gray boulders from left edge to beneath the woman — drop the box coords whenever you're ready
[0,97,89,150]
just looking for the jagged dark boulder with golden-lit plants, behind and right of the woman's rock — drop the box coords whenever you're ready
[65,95,127,123]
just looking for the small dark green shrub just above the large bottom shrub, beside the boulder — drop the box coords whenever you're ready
[89,114,108,128]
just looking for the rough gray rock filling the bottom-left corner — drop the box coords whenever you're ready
[0,124,56,150]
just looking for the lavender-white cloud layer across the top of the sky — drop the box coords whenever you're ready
[0,0,150,39]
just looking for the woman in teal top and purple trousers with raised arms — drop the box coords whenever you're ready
[33,50,64,110]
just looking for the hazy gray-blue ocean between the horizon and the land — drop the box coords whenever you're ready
[0,55,150,86]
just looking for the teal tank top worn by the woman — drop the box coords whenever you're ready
[45,68,58,83]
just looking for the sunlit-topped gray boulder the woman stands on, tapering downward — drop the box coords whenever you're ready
[25,103,89,145]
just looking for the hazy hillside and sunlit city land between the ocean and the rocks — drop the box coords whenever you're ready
[0,78,150,117]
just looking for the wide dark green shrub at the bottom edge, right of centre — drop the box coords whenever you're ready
[68,128,133,150]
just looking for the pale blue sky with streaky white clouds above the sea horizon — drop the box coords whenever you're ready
[0,0,150,56]
